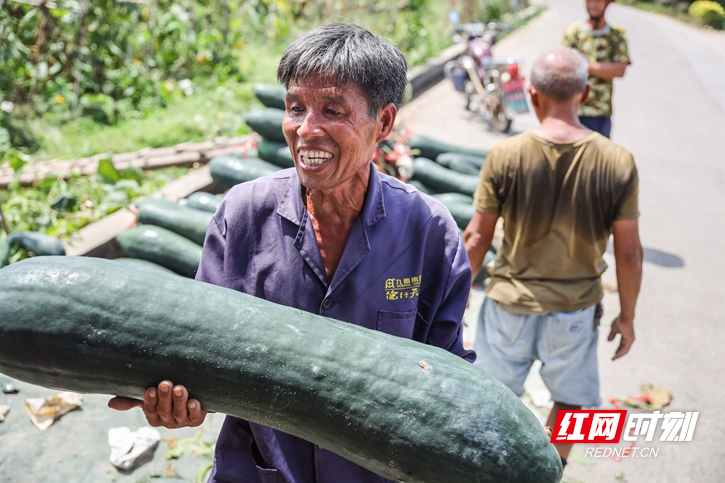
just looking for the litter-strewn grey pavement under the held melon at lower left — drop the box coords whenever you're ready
[0,380,224,483]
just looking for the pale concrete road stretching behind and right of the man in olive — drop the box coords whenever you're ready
[402,0,725,483]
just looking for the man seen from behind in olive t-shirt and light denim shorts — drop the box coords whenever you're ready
[464,49,642,464]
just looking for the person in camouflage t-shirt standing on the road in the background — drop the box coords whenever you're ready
[561,0,631,137]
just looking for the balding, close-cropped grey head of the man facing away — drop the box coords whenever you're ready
[531,48,589,101]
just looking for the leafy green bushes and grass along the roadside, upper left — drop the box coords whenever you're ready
[0,0,532,164]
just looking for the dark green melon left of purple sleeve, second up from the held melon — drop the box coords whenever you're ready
[137,198,214,245]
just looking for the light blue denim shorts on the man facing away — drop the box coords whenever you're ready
[474,297,602,407]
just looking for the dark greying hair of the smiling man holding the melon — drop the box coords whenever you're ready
[277,23,408,117]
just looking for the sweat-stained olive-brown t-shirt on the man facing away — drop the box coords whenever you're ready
[473,132,639,314]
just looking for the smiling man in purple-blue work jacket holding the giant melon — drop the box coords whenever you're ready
[110,24,475,483]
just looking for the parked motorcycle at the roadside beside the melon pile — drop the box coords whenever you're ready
[444,22,529,133]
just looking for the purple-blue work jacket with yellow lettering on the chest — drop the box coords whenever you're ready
[196,164,475,483]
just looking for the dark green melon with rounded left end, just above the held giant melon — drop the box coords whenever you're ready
[116,225,202,278]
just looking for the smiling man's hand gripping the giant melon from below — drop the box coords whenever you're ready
[108,381,208,429]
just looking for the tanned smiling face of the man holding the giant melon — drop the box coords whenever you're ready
[282,76,383,190]
